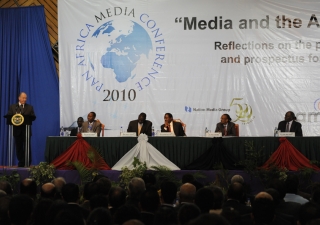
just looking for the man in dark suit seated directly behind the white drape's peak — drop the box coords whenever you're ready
[127,113,152,136]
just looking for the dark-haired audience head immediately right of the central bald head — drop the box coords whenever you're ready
[194,188,214,213]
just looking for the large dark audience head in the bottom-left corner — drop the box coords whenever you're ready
[8,195,33,225]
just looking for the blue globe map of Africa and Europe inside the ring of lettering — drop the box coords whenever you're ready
[92,20,152,83]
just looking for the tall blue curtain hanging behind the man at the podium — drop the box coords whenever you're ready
[0,6,60,165]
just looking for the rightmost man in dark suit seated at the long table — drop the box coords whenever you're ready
[278,111,303,137]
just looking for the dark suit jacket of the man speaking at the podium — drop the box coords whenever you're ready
[7,103,36,137]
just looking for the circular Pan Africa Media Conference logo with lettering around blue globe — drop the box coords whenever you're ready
[76,7,165,91]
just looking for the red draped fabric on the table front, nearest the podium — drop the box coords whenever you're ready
[51,135,111,170]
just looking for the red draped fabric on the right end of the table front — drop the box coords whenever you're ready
[261,137,320,171]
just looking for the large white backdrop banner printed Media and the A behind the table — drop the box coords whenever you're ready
[58,0,320,136]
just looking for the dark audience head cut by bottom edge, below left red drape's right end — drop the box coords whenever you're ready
[87,207,112,225]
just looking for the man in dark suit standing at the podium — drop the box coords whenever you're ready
[7,92,36,167]
